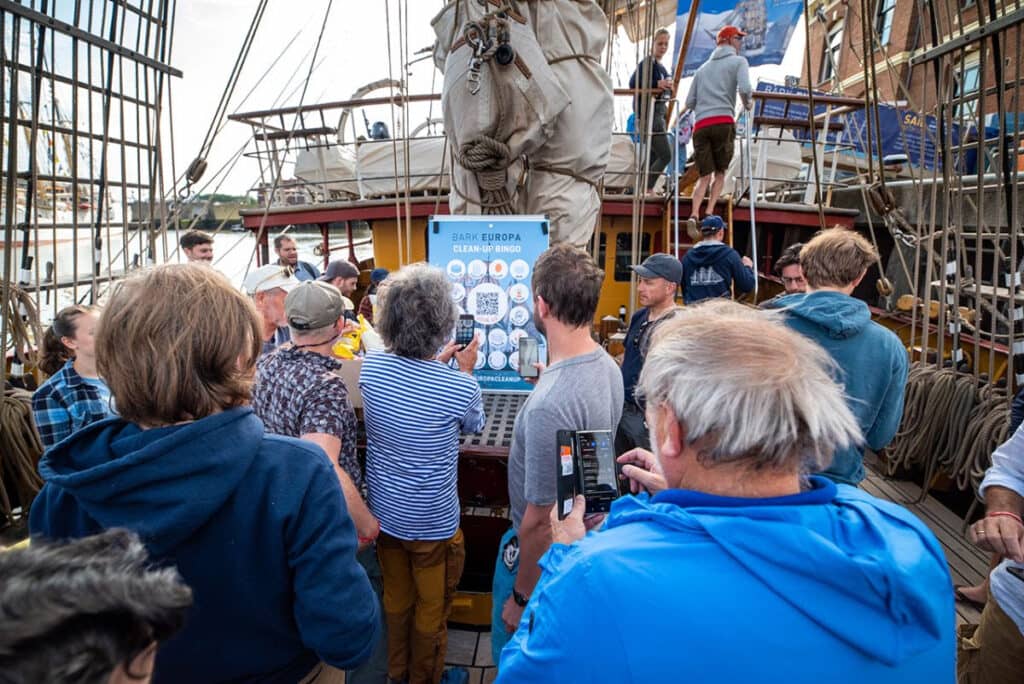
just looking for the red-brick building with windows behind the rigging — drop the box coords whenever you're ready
[802,0,1024,132]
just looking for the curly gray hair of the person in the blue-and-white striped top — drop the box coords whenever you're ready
[376,262,457,358]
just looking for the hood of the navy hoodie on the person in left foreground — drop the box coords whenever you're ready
[39,408,263,554]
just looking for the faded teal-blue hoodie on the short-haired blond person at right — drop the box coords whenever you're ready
[777,291,909,484]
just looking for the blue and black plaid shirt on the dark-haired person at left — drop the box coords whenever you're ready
[32,359,117,448]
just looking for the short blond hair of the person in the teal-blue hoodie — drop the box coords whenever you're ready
[800,226,879,288]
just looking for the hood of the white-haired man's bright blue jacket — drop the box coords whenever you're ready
[605,477,953,666]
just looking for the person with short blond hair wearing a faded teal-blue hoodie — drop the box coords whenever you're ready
[776,227,909,485]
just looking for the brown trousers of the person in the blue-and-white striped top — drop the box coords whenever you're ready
[377,529,466,684]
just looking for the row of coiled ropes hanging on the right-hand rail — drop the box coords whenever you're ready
[887,364,1010,497]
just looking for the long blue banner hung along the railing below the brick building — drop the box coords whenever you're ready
[754,83,962,173]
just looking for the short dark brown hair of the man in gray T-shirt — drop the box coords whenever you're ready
[532,243,604,328]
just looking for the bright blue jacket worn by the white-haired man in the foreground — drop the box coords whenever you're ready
[498,477,955,684]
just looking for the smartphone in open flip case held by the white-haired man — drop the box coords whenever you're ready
[556,430,623,520]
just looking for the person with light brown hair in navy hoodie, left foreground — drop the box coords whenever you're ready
[29,264,381,684]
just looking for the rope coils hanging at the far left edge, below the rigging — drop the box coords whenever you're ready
[0,388,43,523]
